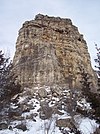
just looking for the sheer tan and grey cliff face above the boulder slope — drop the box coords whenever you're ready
[13,14,96,88]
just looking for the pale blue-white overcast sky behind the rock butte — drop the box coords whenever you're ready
[0,0,100,67]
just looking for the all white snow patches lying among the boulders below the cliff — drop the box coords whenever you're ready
[0,87,98,134]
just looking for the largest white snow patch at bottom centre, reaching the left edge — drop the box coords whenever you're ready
[0,118,61,134]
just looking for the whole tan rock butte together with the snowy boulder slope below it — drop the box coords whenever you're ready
[0,14,99,134]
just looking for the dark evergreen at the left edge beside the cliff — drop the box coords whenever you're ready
[0,51,21,101]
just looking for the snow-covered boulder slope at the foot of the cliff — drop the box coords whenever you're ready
[0,87,97,134]
